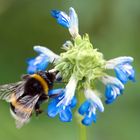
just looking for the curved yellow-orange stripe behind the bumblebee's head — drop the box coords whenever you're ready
[31,74,49,94]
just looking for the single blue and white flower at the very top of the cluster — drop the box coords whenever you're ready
[51,7,79,38]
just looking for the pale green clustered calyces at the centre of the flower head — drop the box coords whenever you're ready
[55,34,105,87]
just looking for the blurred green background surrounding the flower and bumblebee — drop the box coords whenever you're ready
[0,0,140,140]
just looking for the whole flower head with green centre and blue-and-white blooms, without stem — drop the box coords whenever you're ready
[28,8,135,126]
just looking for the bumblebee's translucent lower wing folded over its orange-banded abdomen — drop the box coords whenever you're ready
[11,95,39,128]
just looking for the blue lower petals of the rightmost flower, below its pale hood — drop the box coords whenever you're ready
[115,63,135,84]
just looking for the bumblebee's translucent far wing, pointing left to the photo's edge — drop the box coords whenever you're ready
[0,81,25,102]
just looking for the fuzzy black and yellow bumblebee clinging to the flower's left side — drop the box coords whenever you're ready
[0,71,57,128]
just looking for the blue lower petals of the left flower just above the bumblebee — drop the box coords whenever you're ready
[27,54,49,74]
